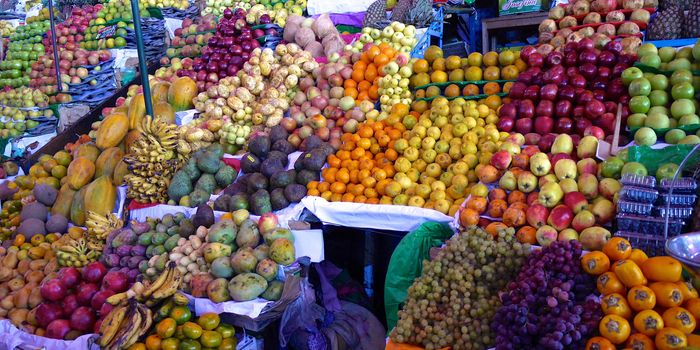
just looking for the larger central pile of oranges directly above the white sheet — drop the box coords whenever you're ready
[307,104,409,208]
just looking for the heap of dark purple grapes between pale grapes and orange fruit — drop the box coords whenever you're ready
[491,241,602,350]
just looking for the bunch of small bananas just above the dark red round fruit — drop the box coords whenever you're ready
[52,227,104,267]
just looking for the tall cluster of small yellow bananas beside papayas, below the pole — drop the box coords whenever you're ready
[124,116,182,203]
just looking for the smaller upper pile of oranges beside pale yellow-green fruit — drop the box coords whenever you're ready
[343,43,398,105]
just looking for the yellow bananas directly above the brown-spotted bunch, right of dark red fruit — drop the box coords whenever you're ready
[107,261,187,307]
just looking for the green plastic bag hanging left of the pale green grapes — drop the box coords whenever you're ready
[384,222,454,332]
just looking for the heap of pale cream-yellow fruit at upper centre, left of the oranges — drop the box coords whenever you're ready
[194,43,318,127]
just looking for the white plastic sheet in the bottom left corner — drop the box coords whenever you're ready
[0,320,100,350]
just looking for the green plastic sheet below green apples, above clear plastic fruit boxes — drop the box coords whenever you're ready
[627,145,700,175]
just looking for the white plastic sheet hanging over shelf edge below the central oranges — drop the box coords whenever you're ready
[301,197,453,232]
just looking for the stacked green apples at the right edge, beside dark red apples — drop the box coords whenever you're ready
[623,41,700,146]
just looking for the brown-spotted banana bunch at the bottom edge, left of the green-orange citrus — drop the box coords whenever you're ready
[97,299,153,350]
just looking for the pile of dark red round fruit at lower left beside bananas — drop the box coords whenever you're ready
[27,262,129,340]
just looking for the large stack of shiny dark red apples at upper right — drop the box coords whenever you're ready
[499,39,636,141]
